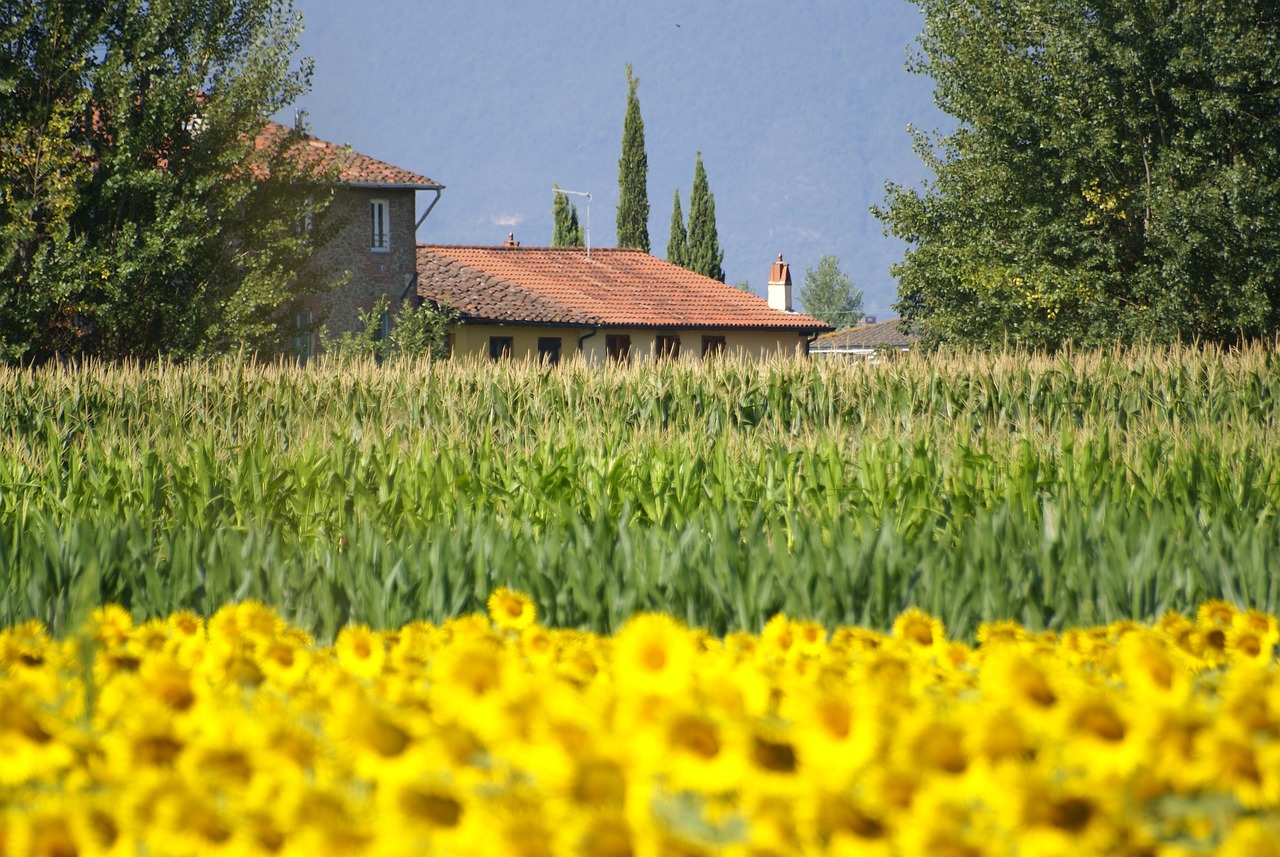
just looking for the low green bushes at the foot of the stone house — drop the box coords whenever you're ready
[320,294,457,362]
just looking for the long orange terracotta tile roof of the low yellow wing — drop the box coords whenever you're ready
[417,246,831,331]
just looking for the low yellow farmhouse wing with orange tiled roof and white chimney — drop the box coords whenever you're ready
[417,237,831,363]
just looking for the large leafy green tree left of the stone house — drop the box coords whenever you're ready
[0,0,334,362]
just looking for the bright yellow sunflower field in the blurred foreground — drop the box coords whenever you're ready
[0,588,1280,857]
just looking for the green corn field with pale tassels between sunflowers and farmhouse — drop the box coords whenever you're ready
[0,347,1280,640]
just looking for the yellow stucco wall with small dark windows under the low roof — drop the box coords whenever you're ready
[453,325,806,362]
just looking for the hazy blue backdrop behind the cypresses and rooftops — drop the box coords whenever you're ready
[282,0,951,321]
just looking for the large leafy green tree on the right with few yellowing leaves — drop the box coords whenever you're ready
[873,0,1280,347]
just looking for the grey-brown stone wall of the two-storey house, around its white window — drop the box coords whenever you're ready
[305,187,417,350]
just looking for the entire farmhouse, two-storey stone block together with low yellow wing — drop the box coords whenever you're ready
[272,123,831,362]
